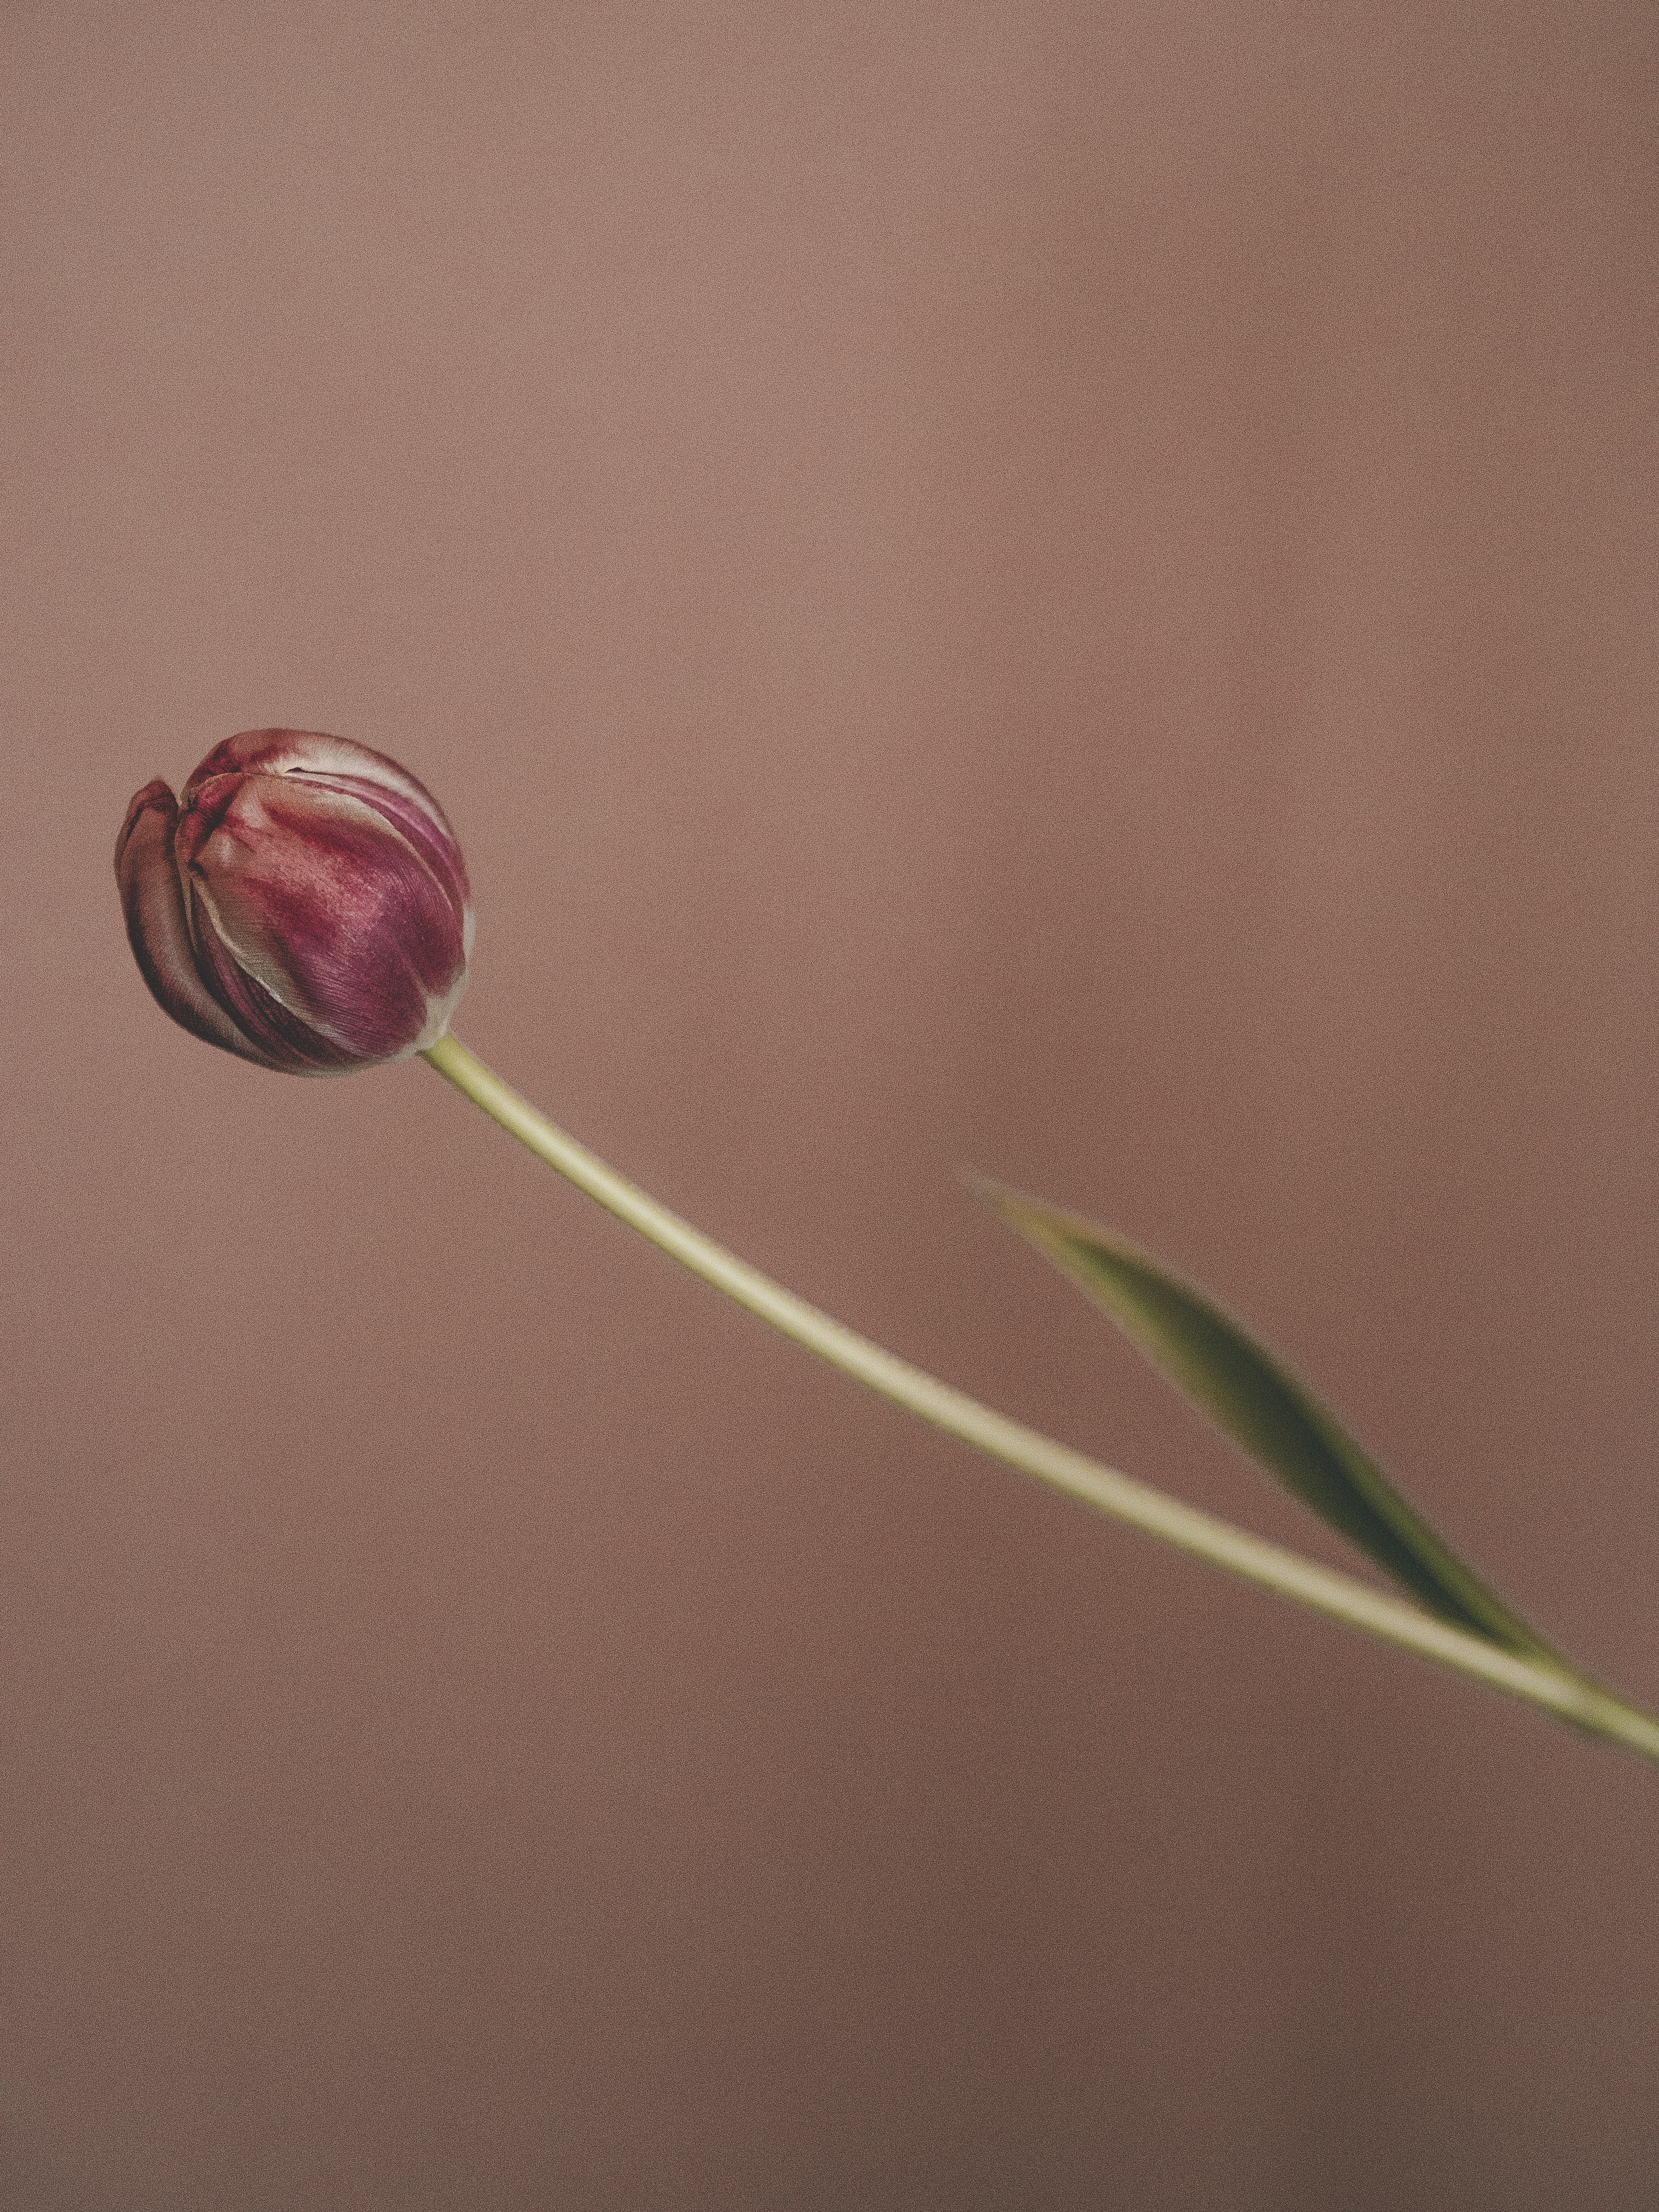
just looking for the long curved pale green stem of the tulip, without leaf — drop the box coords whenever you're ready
[422,1037,1659,1765]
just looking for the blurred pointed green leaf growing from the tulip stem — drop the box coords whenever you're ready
[974,1177,1562,1663]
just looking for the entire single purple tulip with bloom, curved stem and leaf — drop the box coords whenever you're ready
[115,730,1659,1765]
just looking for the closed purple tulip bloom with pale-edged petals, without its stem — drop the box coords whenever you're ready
[115,730,473,1075]
